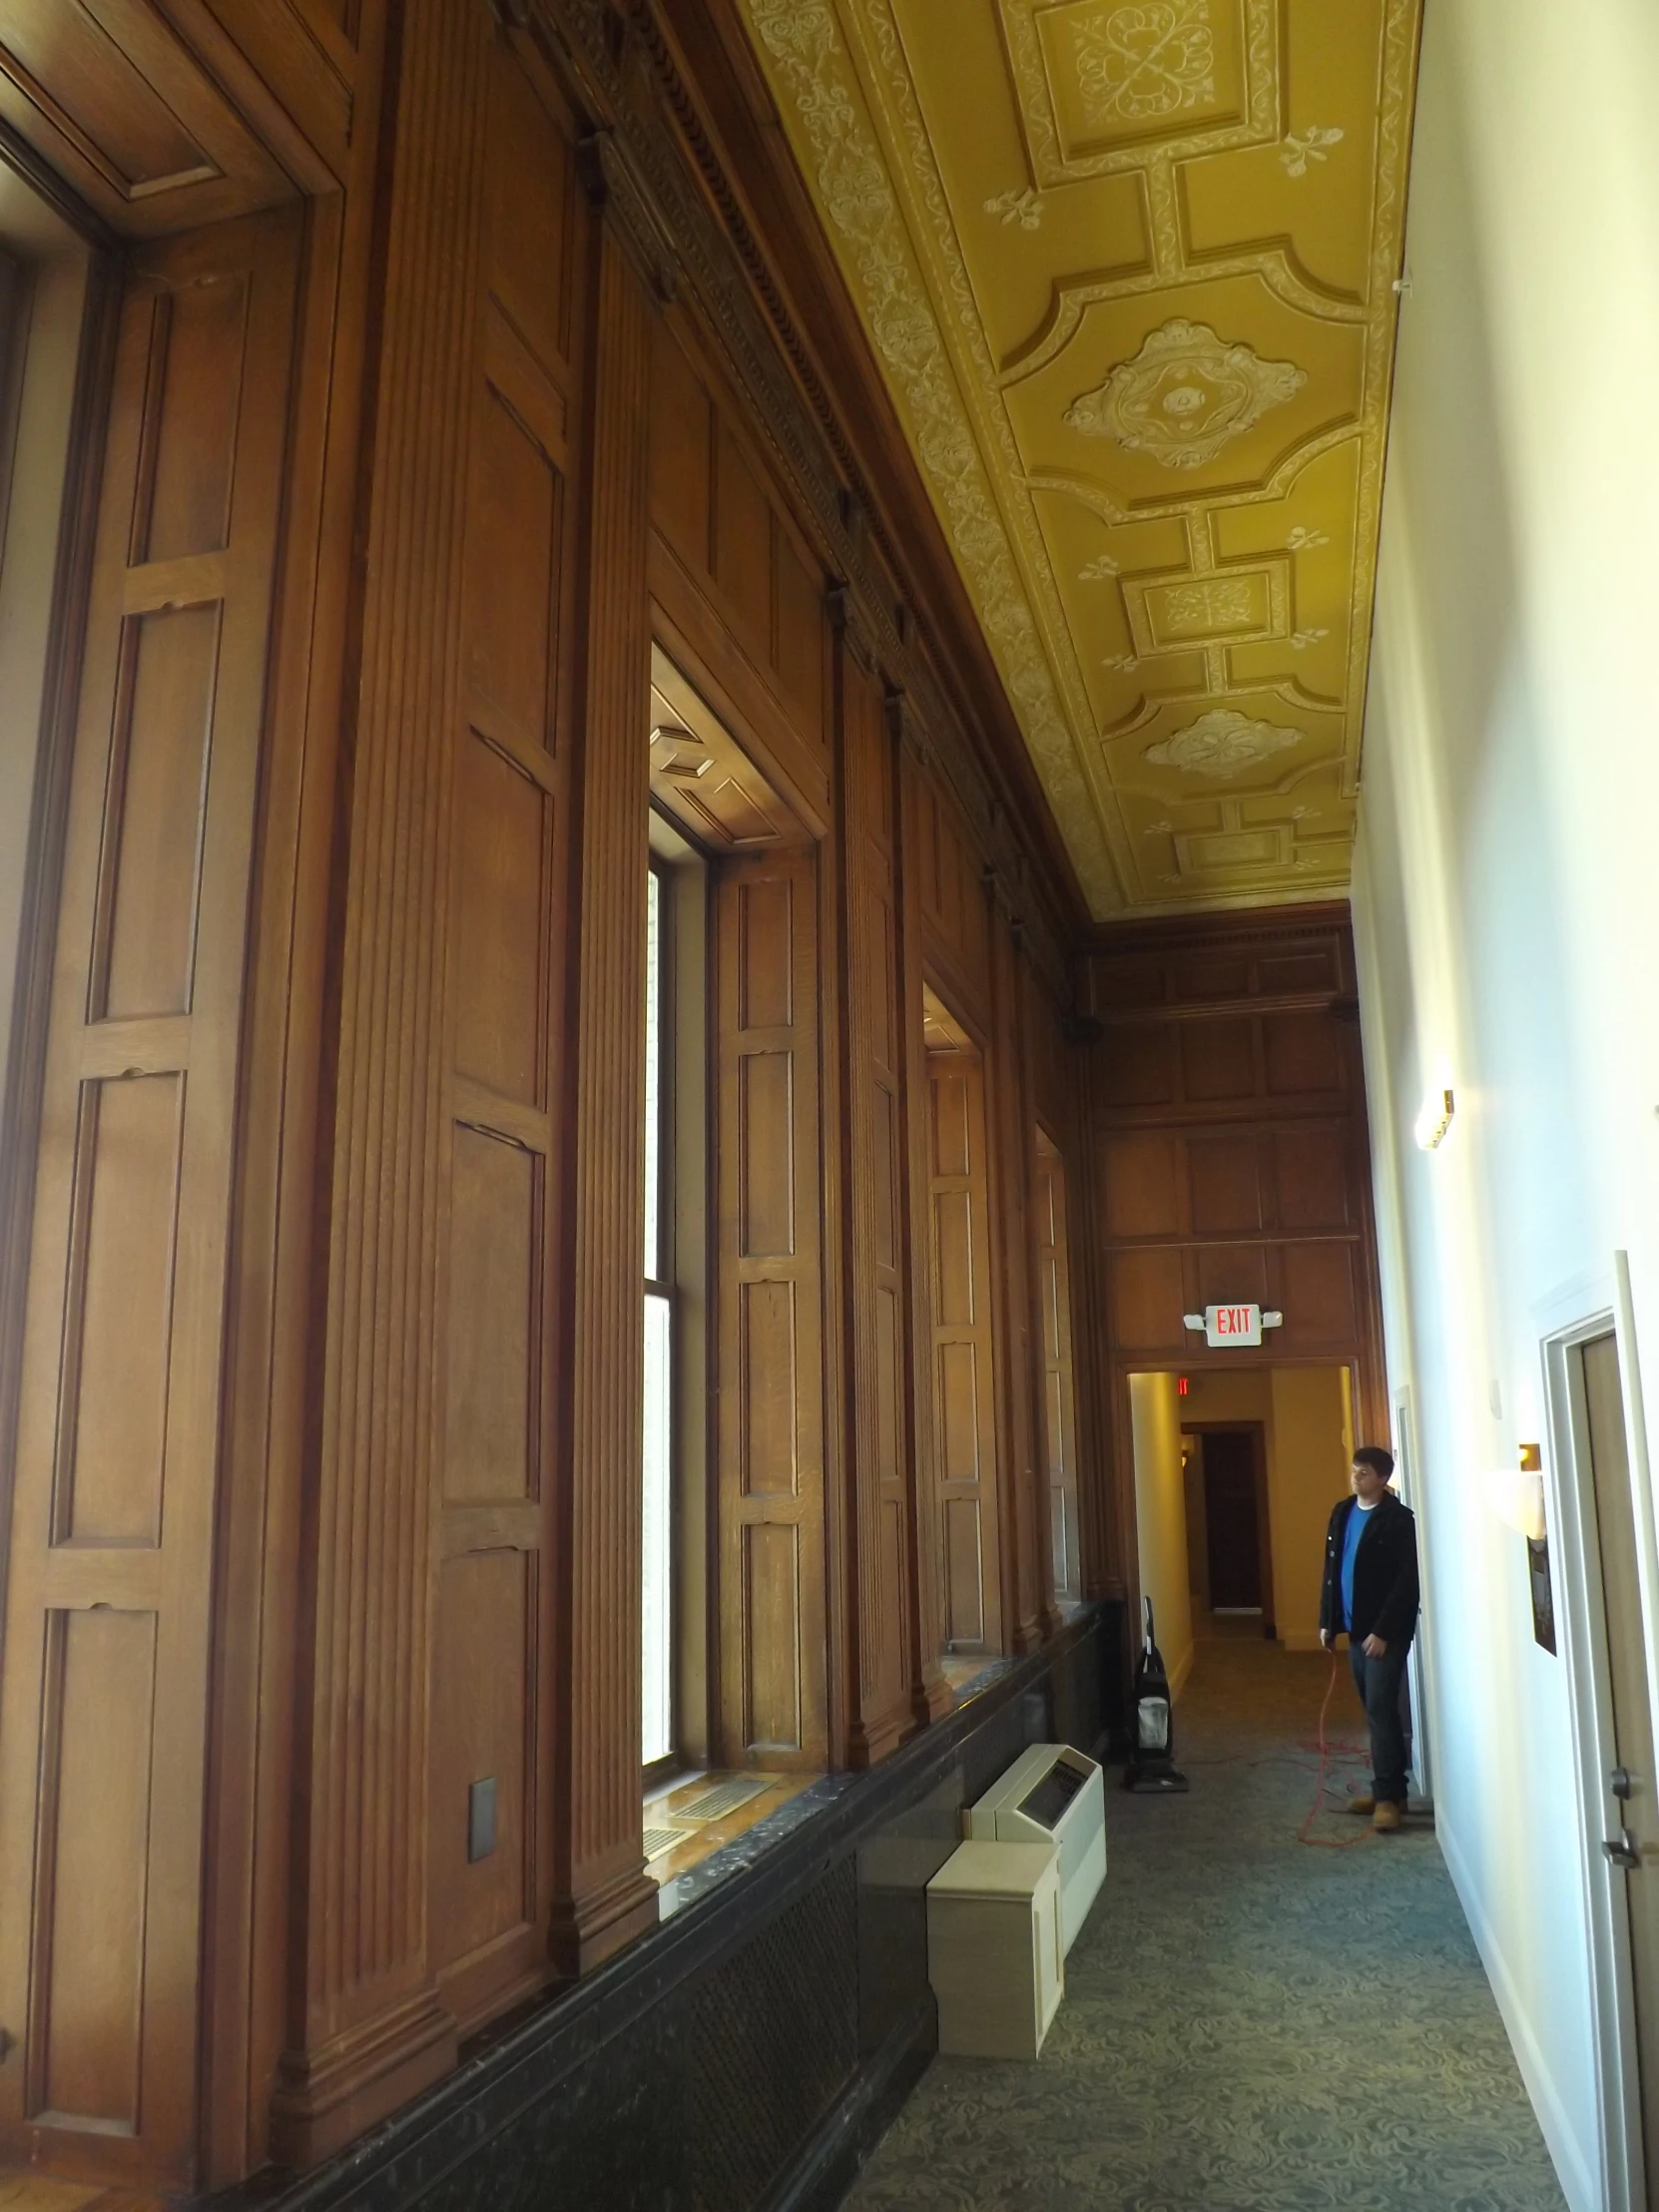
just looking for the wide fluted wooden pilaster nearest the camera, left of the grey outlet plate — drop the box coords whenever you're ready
[273,0,491,2163]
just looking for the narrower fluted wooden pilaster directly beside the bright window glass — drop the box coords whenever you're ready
[551,142,657,1973]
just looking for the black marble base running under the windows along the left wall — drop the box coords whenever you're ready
[197,1604,1122,2212]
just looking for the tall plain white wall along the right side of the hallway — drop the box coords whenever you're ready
[1354,0,1659,2208]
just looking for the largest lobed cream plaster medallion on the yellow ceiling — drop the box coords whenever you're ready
[1066,316,1308,469]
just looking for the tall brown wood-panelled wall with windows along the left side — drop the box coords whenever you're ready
[0,0,1123,2188]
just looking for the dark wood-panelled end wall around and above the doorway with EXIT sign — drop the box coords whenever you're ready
[1086,907,1386,1619]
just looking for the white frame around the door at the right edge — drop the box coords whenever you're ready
[1539,1252,1659,2212]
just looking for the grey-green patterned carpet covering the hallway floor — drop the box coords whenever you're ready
[847,1637,1564,2212]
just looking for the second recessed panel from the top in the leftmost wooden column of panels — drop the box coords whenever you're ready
[93,606,219,1020]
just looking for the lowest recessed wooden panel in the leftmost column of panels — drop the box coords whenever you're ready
[31,1608,155,2137]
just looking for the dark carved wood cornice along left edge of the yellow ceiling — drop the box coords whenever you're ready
[529,0,1071,995]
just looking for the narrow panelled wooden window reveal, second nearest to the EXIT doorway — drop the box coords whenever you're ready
[927,1053,1002,1652]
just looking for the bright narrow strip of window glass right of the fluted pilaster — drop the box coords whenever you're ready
[642,867,675,1765]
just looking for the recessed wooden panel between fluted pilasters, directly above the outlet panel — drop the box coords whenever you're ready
[442,1124,544,1504]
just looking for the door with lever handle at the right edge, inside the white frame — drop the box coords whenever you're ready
[1577,1332,1659,2199]
